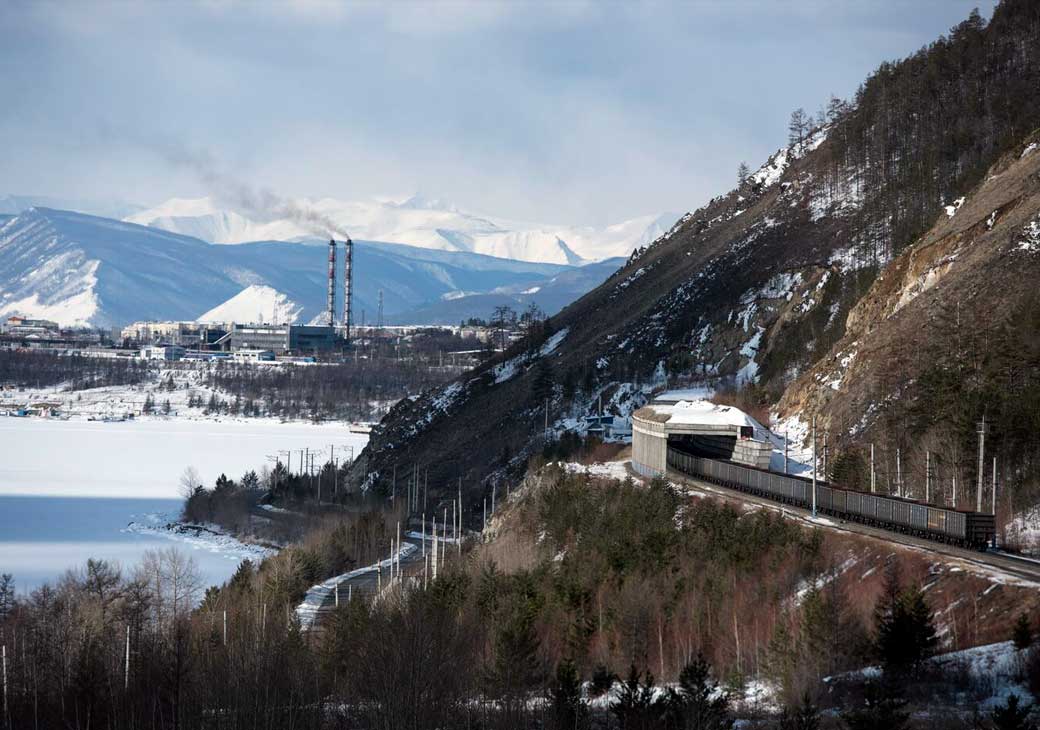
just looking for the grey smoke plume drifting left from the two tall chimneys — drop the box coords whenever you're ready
[151,140,348,239]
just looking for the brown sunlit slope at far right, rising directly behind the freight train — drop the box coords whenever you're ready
[779,128,1040,524]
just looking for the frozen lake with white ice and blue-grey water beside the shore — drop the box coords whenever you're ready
[0,418,368,593]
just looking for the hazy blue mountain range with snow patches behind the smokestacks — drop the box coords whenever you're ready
[0,207,623,325]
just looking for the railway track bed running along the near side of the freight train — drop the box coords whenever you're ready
[661,469,1040,588]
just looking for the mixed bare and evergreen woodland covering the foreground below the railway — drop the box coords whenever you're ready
[0,469,1040,730]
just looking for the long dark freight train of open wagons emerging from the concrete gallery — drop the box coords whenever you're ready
[668,445,996,550]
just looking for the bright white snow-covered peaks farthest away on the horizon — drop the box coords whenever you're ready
[126,195,677,265]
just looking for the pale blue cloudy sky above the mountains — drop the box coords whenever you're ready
[0,0,994,226]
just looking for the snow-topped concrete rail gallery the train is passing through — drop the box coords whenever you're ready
[632,391,773,476]
